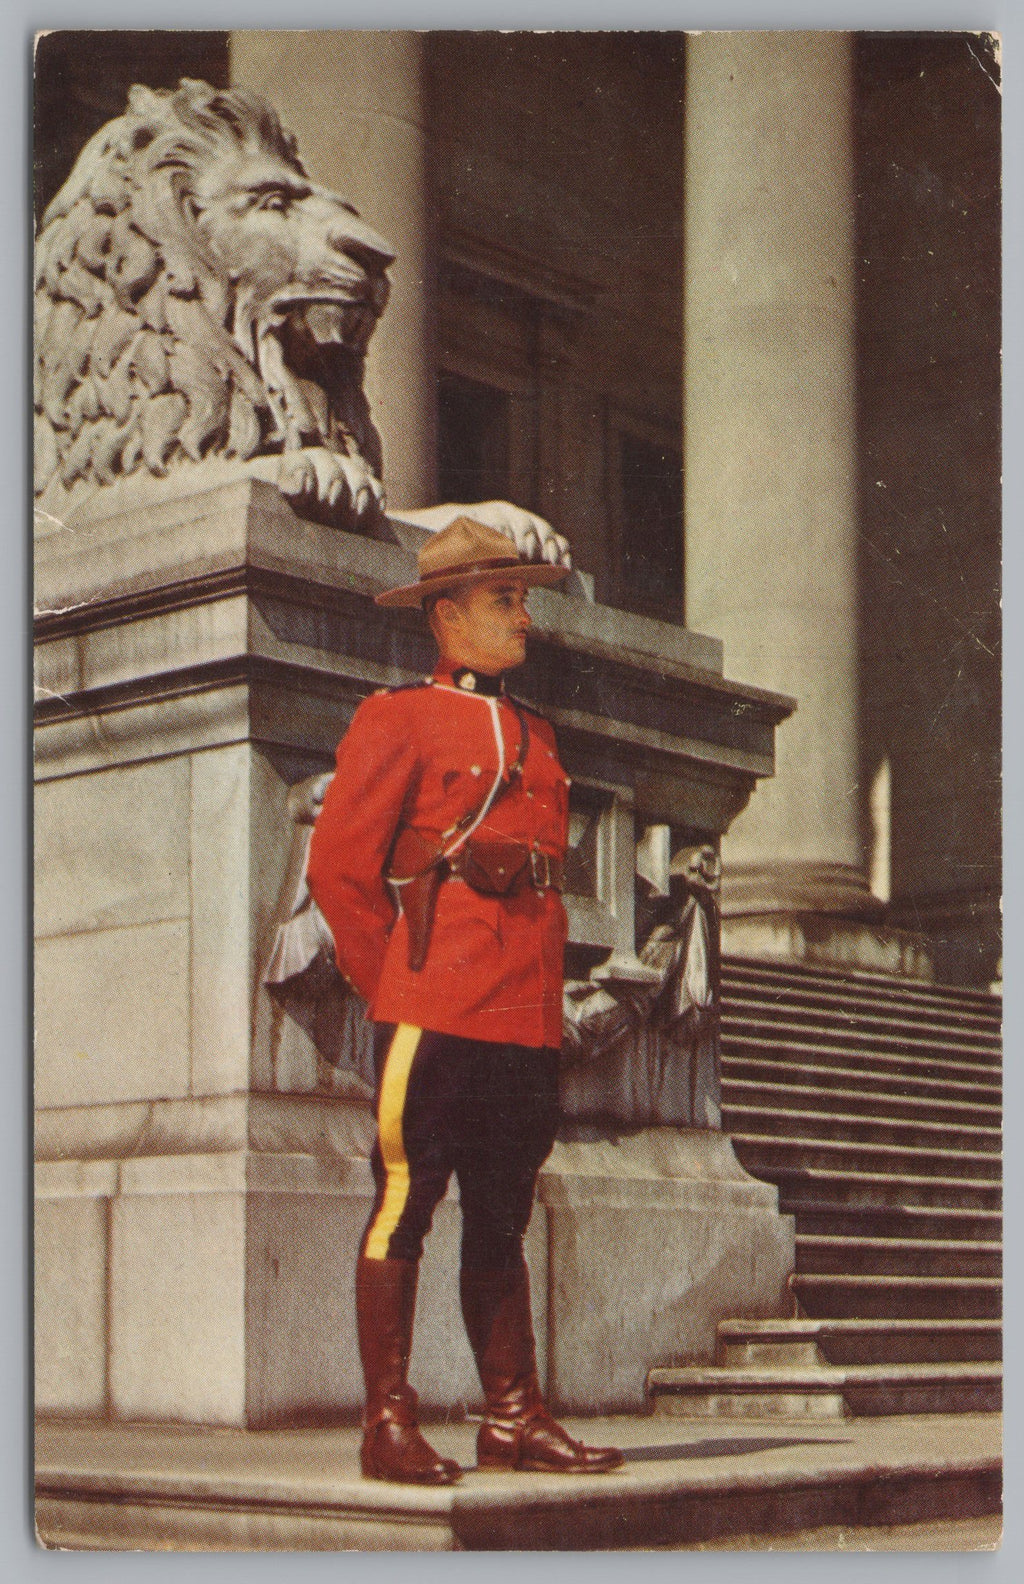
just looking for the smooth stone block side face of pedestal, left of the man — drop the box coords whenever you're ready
[35,744,252,1110]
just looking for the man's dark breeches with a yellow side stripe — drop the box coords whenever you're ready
[363,1023,558,1269]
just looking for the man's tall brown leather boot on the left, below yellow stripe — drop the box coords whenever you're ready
[355,1256,461,1484]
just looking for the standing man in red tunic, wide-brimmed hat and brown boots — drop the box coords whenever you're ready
[309,516,623,1484]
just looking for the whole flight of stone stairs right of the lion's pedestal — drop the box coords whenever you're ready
[648,958,1002,1418]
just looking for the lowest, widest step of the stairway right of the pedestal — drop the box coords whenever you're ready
[647,1361,1002,1419]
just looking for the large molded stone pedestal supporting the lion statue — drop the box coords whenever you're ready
[36,474,793,1426]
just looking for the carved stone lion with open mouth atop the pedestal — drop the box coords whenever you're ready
[35,79,569,564]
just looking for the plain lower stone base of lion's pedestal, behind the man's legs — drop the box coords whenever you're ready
[35,1140,794,1429]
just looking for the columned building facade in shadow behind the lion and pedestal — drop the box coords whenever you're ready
[36,32,1000,984]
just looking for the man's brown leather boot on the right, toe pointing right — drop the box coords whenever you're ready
[461,1264,623,1475]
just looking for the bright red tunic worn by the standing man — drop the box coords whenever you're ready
[308,670,569,1047]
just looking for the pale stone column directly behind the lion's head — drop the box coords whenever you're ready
[231,30,437,508]
